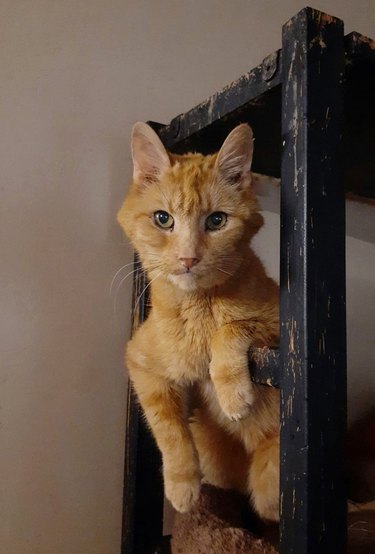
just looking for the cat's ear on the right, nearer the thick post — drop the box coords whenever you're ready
[216,123,254,184]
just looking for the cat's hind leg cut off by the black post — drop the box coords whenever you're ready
[249,435,280,521]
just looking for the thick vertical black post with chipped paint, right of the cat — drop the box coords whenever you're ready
[280,8,346,554]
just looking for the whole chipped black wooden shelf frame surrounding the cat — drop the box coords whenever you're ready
[122,8,375,554]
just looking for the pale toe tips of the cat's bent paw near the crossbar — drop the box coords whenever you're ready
[218,381,254,421]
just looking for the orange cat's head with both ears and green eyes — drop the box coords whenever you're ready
[118,123,262,290]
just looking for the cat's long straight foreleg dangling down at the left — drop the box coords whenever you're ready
[127,342,201,512]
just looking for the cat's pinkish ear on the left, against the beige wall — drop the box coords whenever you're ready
[131,121,171,184]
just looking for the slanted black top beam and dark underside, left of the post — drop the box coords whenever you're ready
[155,55,281,177]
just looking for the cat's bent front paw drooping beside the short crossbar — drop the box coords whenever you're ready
[211,362,255,421]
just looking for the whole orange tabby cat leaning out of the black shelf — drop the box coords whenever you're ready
[118,123,279,520]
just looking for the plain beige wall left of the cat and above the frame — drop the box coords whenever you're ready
[0,0,375,554]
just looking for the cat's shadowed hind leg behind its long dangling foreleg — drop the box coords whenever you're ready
[190,406,250,494]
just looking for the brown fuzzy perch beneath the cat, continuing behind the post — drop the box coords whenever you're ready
[171,485,375,554]
